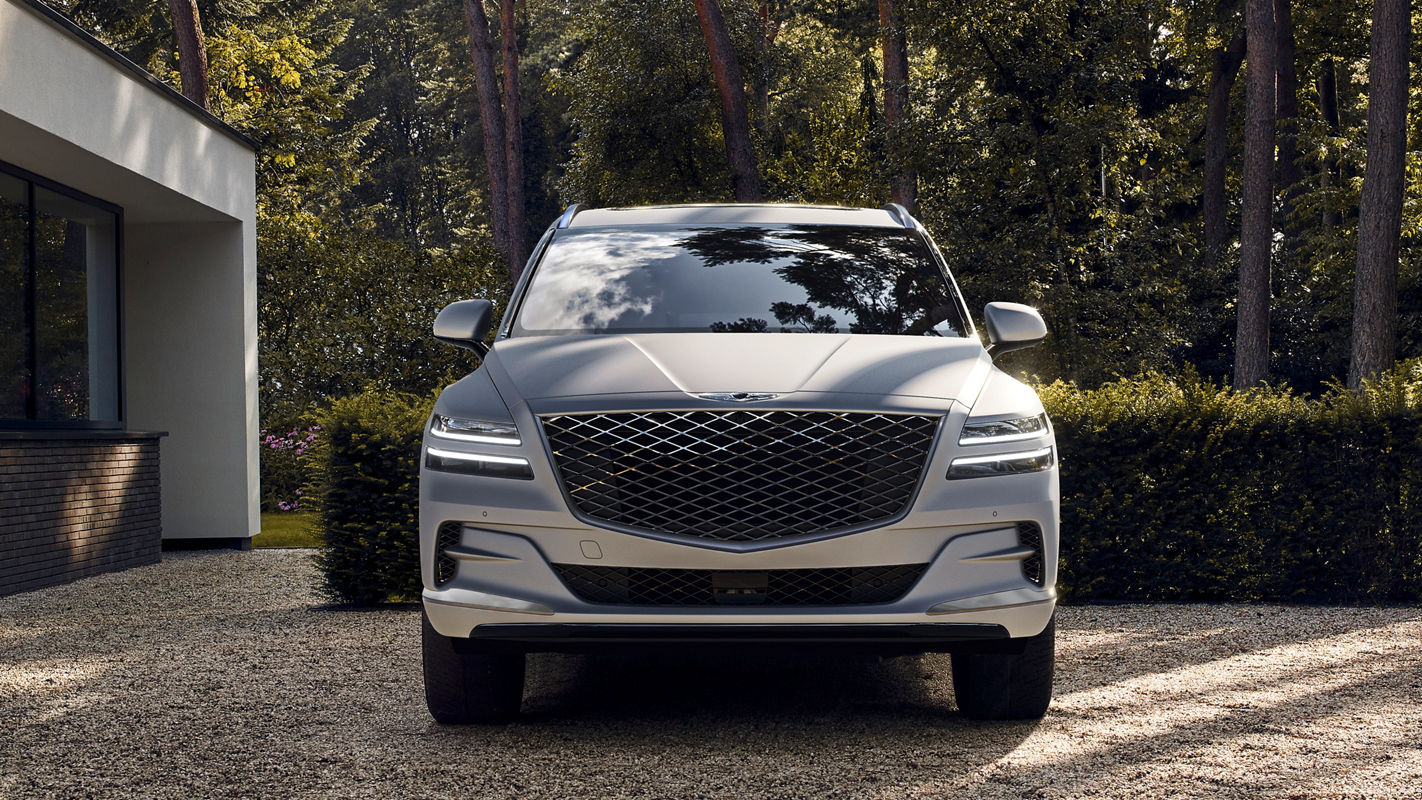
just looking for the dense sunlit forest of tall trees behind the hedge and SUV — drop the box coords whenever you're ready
[44,0,1422,419]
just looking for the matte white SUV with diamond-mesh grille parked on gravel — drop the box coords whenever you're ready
[419,205,1058,722]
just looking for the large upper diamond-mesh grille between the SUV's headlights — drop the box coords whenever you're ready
[542,411,939,541]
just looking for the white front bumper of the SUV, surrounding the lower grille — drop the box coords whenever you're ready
[419,398,1058,651]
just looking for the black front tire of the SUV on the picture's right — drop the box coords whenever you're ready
[953,615,1057,719]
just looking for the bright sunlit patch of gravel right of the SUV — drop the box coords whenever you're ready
[883,612,1422,797]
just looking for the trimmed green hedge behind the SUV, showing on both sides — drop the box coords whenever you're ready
[307,360,1422,604]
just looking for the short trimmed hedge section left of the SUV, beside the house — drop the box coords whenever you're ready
[309,391,434,605]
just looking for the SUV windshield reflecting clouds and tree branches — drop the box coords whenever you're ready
[513,225,966,337]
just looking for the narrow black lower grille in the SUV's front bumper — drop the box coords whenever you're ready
[553,564,927,605]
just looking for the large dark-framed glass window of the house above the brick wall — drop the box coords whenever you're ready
[0,162,119,423]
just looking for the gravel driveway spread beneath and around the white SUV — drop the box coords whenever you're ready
[0,550,1422,800]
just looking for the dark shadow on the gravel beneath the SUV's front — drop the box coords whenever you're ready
[422,649,1038,796]
